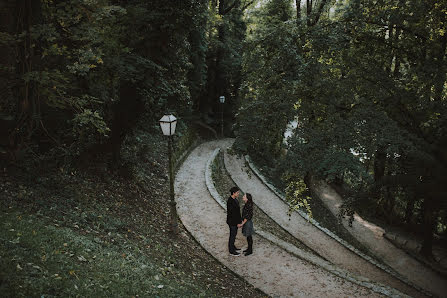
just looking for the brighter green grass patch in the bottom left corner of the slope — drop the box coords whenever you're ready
[1,210,173,297]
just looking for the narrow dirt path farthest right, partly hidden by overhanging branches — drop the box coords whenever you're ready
[313,182,447,297]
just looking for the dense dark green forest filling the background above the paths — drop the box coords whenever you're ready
[0,0,447,256]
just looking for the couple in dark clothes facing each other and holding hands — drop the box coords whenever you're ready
[227,187,254,256]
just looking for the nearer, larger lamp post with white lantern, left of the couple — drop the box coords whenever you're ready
[160,115,178,234]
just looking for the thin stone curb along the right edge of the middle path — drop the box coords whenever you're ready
[245,155,433,297]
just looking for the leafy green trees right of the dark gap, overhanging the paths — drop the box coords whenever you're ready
[237,0,447,255]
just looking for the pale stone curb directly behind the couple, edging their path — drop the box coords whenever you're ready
[205,148,410,298]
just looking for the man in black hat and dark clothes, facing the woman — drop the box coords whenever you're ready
[227,186,242,256]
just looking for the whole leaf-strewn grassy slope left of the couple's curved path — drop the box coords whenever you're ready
[0,133,262,297]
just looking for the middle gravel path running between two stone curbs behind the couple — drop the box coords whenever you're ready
[225,145,422,297]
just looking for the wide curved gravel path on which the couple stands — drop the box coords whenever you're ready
[175,140,378,297]
